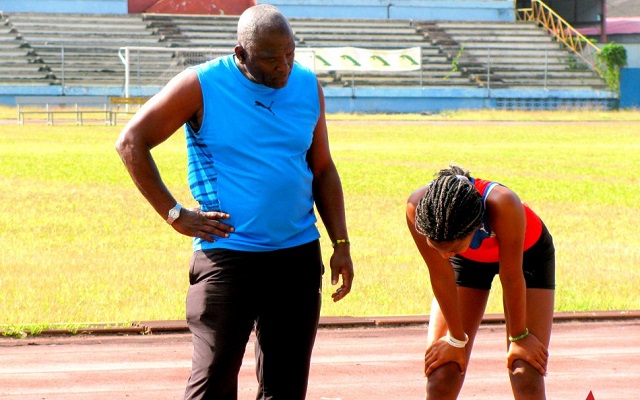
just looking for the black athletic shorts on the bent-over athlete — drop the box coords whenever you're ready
[449,224,556,290]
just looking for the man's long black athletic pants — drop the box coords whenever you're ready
[185,240,323,400]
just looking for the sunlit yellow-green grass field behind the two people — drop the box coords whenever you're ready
[0,108,640,329]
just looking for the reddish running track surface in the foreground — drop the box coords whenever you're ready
[0,319,640,400]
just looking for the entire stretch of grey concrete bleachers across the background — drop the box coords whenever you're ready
[0,13,606,89]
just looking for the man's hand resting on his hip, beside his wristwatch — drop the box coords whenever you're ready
[171,208,233,242]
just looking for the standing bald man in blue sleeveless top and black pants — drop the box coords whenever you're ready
[116,4,353,400]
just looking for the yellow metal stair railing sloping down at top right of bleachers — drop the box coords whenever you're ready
[518,0,605,78]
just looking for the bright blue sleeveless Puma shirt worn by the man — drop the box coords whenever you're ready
[185,55,320,251]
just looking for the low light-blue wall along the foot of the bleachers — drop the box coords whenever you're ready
[0,86,618,113]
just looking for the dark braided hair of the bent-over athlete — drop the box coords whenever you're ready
[415,165,484,242]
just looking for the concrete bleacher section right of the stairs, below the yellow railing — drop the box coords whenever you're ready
[417,22,607,89]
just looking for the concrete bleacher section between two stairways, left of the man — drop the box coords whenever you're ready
[0,13,162,86]
